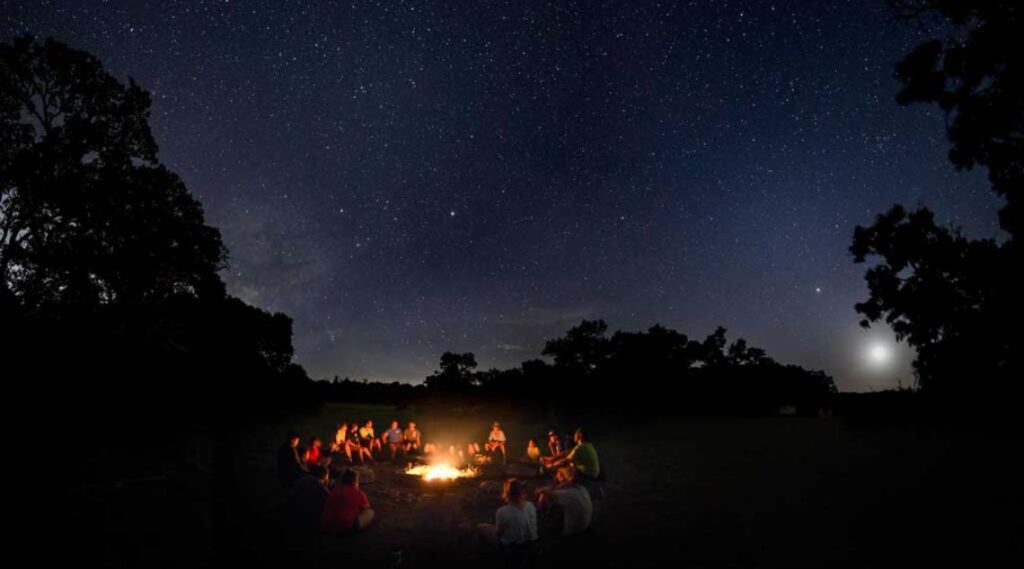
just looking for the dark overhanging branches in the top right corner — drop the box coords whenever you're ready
[890,0,1024,238]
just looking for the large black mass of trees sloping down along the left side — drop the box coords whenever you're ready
[0,37,309,431]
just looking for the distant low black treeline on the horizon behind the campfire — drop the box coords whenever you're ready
[317,320,836,413]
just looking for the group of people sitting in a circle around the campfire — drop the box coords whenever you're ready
[278,421,601,555]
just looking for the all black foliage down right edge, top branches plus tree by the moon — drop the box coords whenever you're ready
[851,0,1024,410]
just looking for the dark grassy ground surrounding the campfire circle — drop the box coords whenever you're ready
[81,405,1024,567]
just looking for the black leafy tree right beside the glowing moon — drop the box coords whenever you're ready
[851,206,1021,395]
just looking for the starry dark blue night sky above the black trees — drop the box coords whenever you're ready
[0,0,998,390]
